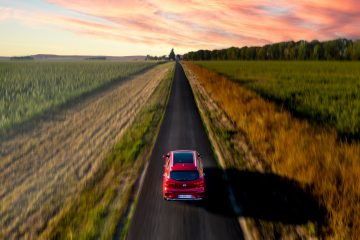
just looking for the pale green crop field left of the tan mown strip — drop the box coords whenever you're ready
[0,61,156,131]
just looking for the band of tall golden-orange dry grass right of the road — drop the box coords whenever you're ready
[185,63,360,239]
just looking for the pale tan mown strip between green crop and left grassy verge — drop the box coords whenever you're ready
[0,64,170,239]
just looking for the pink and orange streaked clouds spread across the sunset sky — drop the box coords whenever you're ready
[4,0,360,50]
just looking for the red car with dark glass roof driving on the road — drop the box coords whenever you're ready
[163,150,205,200]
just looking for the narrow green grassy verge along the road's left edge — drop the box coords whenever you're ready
[40,63,173,239]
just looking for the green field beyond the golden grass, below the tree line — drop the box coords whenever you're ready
[195,61,360,138]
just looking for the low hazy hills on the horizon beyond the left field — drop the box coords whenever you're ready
[0,54,146,61]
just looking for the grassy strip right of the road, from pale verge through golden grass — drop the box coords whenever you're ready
[184,63,360,239]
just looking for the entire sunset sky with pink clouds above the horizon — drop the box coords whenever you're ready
[0,0,360,56]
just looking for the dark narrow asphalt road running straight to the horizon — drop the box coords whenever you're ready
[128,63,243,240]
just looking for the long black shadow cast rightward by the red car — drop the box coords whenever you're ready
[181,168,326,225]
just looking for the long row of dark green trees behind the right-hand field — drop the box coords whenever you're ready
[182,39,360,61]
